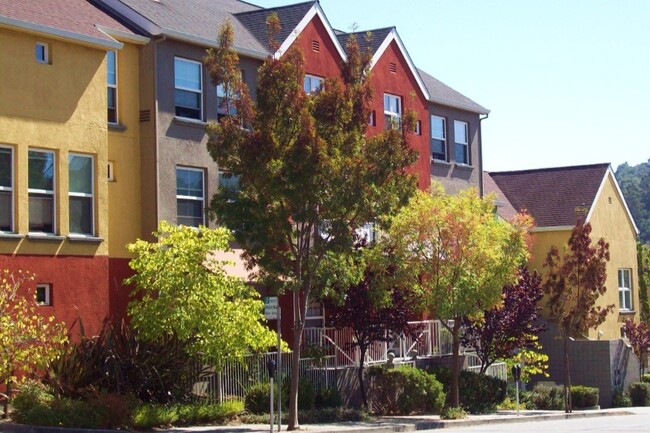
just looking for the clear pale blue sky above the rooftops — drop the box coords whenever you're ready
[250,0,650,171]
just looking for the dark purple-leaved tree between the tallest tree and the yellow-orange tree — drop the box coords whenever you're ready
[325,264,421,408]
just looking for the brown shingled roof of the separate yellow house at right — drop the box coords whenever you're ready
[484,164,609,227]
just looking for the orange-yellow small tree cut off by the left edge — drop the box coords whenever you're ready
[0,269,67,417]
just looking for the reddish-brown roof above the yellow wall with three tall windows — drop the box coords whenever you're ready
[0,0,139,49]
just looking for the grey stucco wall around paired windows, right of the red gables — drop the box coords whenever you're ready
[429,103,483,194]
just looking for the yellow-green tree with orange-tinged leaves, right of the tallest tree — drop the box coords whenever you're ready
[387,185,530,407]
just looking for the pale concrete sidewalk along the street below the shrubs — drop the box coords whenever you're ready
[161,408,634,433]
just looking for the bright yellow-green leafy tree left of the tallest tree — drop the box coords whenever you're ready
[126,221,276,366]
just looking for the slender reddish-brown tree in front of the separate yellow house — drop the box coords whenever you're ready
[542,221,614,412]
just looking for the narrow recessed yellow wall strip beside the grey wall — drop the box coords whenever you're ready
[104,43,141,258]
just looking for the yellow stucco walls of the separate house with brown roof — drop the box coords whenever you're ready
[529,175,639,339]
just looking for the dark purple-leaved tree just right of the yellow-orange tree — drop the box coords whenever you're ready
[463,267,545,373]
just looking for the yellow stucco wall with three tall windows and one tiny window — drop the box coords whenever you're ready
[0,29,109,255]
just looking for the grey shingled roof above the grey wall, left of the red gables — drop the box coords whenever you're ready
[97,0,268,58]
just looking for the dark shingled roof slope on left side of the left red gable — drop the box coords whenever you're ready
[235,1,317,52]
